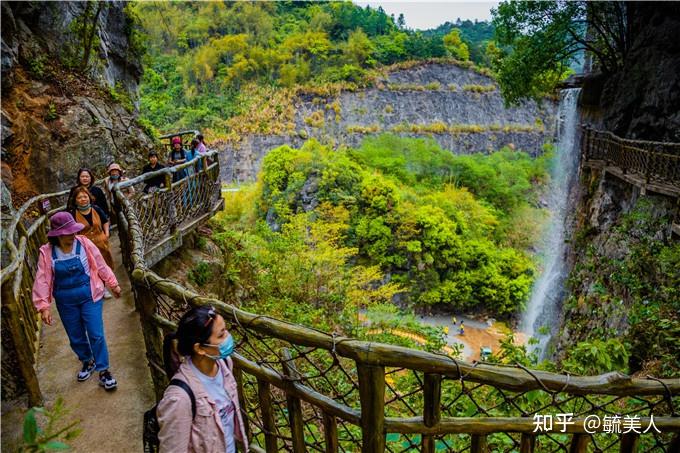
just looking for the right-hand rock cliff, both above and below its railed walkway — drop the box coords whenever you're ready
[556,2,680,376]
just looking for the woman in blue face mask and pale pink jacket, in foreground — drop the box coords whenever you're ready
[156,307,248,453]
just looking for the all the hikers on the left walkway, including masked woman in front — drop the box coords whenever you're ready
[32,132,248,453]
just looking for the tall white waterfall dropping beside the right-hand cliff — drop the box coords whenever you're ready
[521,88,581,358]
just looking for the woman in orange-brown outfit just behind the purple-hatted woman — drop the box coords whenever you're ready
[72,186,113,299]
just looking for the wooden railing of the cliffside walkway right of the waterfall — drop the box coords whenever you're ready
[581,126,680,194]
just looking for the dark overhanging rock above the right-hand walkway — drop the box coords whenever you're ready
[582,2,680,142]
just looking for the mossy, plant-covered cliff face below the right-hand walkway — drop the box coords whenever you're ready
[556,167,680,374]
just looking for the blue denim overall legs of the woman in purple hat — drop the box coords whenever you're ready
[57,298,109,371]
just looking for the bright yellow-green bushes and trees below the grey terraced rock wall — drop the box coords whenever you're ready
[218,135,550,327]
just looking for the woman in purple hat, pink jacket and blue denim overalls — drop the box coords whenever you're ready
[33,212,120,390]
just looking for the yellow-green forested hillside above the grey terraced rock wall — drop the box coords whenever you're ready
[133,1,491,135]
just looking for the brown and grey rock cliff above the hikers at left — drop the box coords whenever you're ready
[2,1,151,204]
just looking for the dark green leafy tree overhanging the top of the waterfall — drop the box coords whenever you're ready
[493,1,631,103]
